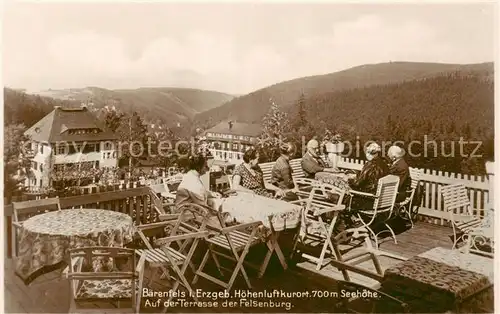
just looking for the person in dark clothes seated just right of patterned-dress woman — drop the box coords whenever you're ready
[271,143,299,201]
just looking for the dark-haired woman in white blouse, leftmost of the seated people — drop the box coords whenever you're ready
[175,155,220,223]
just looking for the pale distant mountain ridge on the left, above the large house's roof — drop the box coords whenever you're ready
[28,87,234,124]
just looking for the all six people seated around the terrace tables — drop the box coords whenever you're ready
[171,139,411,213]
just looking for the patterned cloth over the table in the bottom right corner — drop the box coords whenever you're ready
[382,248,494,313]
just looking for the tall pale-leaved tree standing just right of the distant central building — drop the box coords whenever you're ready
[257,100,291,160]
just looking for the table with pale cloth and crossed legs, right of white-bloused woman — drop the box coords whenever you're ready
[221,192,302,277]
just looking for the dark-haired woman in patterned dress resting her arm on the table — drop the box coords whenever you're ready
[233,148,284,197]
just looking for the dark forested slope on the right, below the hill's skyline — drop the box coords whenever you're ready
[278,74,494,174]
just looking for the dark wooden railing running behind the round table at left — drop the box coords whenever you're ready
[4,187,157,257]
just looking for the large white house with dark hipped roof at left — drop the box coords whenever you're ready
[24,106,118,188]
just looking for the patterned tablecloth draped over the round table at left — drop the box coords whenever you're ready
[15,209,135,283]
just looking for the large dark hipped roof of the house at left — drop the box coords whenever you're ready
[24,107,117,143]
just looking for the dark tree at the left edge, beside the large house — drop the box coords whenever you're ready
[3,124,32,202]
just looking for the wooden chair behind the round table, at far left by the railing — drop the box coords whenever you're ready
[12,197,61,256]
